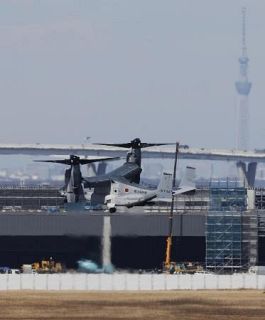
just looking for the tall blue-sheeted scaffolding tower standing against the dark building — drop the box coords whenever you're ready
[206,188,258,273]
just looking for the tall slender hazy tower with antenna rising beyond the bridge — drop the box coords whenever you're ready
[235,7,251,150]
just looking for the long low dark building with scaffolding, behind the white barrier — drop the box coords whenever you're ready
[0,187,265,273]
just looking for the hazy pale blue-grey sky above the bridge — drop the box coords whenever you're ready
[0,0,265,148]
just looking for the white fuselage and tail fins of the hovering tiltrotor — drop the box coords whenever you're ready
[105,167,196,212]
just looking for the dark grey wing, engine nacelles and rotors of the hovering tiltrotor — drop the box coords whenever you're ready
[38,138,192,205]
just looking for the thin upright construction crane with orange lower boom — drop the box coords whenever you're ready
[163,142,179,272]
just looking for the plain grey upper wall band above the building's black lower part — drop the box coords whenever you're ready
[0,212,205,237]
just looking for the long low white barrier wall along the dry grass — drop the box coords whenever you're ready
[0,273,265,291]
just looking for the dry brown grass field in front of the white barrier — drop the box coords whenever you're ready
[0,290,265,320]
